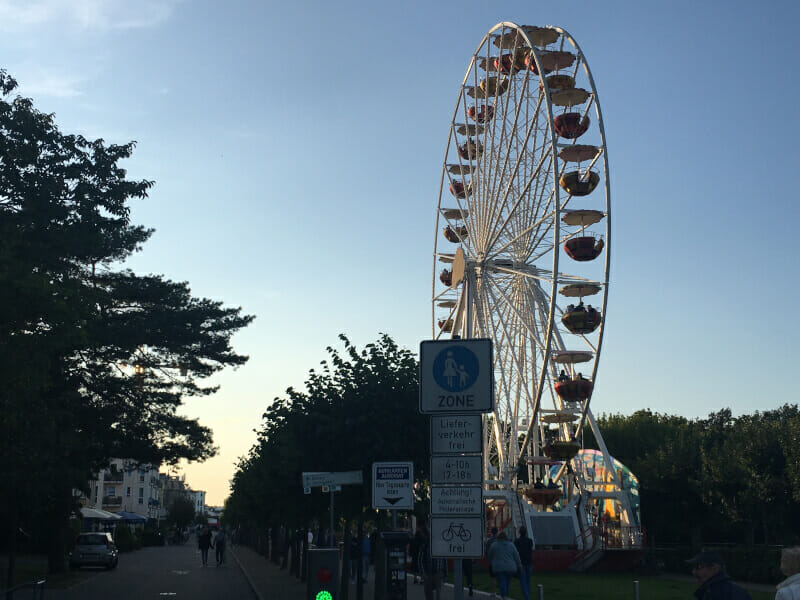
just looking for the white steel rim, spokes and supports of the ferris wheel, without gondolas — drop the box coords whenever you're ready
[431,21,621,496]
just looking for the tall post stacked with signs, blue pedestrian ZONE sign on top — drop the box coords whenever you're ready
[419,339,494,600]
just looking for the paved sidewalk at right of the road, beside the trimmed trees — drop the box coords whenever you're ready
[230,546,490,600]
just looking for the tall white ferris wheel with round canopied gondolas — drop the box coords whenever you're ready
[432,22,632,528]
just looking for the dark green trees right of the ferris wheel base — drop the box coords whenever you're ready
[587,405,800,546]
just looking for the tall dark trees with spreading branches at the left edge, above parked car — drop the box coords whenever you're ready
[0,70,252,586]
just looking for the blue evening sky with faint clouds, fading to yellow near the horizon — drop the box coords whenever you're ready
[0,0,800,505]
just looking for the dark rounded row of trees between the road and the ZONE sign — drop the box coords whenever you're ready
[225,335,428,531]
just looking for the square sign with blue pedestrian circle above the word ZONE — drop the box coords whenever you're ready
[419,339,494,414]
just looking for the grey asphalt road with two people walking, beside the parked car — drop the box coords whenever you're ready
[45,538,255,600]
